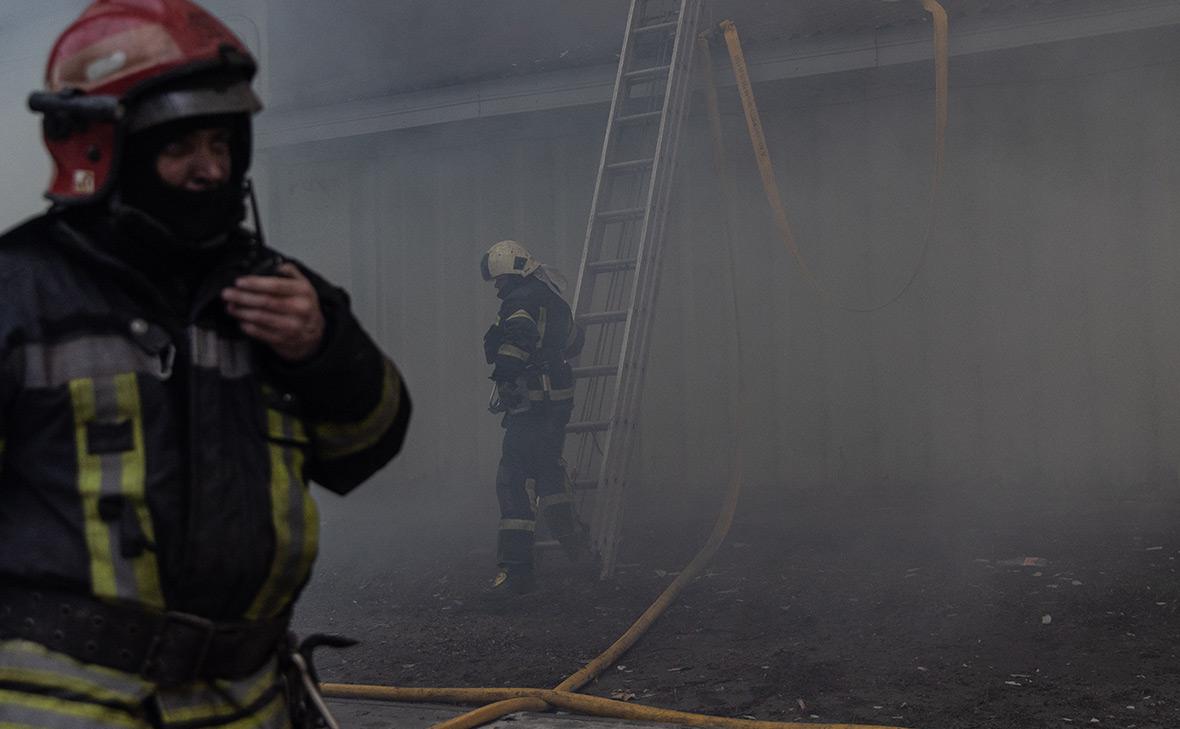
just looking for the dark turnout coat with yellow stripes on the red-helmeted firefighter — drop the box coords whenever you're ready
[0,208,409,620]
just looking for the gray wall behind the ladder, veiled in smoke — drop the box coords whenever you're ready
[263,24,1180,521]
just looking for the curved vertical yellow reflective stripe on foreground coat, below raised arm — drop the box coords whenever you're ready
[245,411,320,619]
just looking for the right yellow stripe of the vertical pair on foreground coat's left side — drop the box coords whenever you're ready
[114,373,164,608]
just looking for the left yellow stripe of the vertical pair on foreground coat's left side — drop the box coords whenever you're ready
[70,379,118,597]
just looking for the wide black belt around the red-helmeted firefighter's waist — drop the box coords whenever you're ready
[0,585,290,687]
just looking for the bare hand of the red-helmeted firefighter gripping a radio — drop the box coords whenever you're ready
[222,262,323,362]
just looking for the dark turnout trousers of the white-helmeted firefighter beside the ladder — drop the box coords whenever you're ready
[496,400,577,566]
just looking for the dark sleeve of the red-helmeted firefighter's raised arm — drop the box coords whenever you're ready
[269,260,411,493]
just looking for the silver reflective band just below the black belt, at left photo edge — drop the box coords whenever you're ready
[0,641,152,707]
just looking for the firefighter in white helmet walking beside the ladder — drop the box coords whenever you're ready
[480,241,586,595]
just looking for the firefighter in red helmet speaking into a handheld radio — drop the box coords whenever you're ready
[0,0,409,728]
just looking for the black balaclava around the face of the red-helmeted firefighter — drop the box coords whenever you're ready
[117,113,250,246]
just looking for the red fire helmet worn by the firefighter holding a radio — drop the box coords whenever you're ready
[28,0,262,204]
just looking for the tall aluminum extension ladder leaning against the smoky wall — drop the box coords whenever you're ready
[565,0,703,577]
